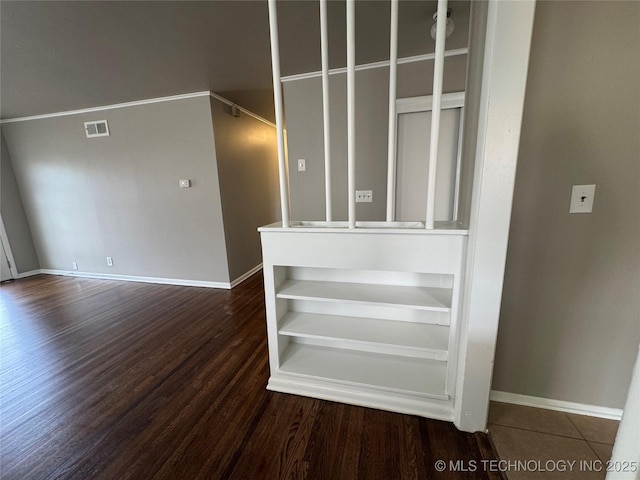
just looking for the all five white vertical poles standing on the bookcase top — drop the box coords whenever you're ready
[269,0,447,229]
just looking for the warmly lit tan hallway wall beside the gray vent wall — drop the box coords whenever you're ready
[211,99,280,280]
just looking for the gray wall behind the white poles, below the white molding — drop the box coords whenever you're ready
[284,55,466,220]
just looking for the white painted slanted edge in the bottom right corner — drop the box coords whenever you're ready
[607,349,640,480]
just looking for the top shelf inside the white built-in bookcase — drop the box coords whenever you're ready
[276,280,451,312]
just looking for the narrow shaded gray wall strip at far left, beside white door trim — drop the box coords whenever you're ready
[0,130,40,273]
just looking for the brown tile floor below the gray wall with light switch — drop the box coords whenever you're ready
[489,402,618,480]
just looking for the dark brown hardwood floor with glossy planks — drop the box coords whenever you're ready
[0,274,498,480]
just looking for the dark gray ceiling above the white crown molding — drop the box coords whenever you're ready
[0,0,469,124]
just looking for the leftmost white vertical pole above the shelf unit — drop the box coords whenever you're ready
[269,0,289,228]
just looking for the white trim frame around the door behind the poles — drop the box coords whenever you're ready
[392,92,465,222]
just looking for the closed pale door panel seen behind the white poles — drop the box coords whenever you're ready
[395,107,462,221]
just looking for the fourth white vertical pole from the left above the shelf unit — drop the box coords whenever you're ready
[387,0,398,222]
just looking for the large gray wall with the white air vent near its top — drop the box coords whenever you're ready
[3,97,229,282]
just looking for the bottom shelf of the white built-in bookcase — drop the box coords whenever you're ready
[280,343,449,400]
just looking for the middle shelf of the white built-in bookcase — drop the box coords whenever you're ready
[279,312,449,361]
